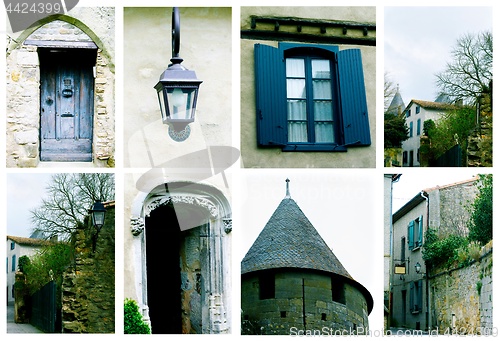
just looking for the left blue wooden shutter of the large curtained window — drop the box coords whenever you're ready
[254,44,288,146]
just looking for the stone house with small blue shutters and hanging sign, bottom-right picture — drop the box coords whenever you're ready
[386,177,478,330]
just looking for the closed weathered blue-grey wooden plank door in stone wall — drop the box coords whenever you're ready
[39,48,96,161]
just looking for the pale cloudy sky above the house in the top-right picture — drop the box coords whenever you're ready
[384,6,493,105]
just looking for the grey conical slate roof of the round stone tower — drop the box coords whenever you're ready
[241,195,352,280]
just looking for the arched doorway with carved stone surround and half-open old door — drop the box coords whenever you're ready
[131,182,232,334]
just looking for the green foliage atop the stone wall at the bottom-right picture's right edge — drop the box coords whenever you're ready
[469,174,493,245]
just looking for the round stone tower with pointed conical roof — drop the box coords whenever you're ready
[241,182,373,335]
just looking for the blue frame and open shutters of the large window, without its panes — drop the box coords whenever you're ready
[254,42,371,152]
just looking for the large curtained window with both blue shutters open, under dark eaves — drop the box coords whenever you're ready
[254,43,371,151]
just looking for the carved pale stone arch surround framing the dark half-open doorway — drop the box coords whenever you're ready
[130,182,232,333]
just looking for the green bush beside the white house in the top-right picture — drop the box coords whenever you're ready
[423,107,476,159]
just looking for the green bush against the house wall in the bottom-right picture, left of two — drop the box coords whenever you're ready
[422,228,468,269]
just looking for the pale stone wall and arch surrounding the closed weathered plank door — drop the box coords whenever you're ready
[6,8,115,167]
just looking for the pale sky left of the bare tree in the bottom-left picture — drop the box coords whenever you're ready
[6,173,52,237]
